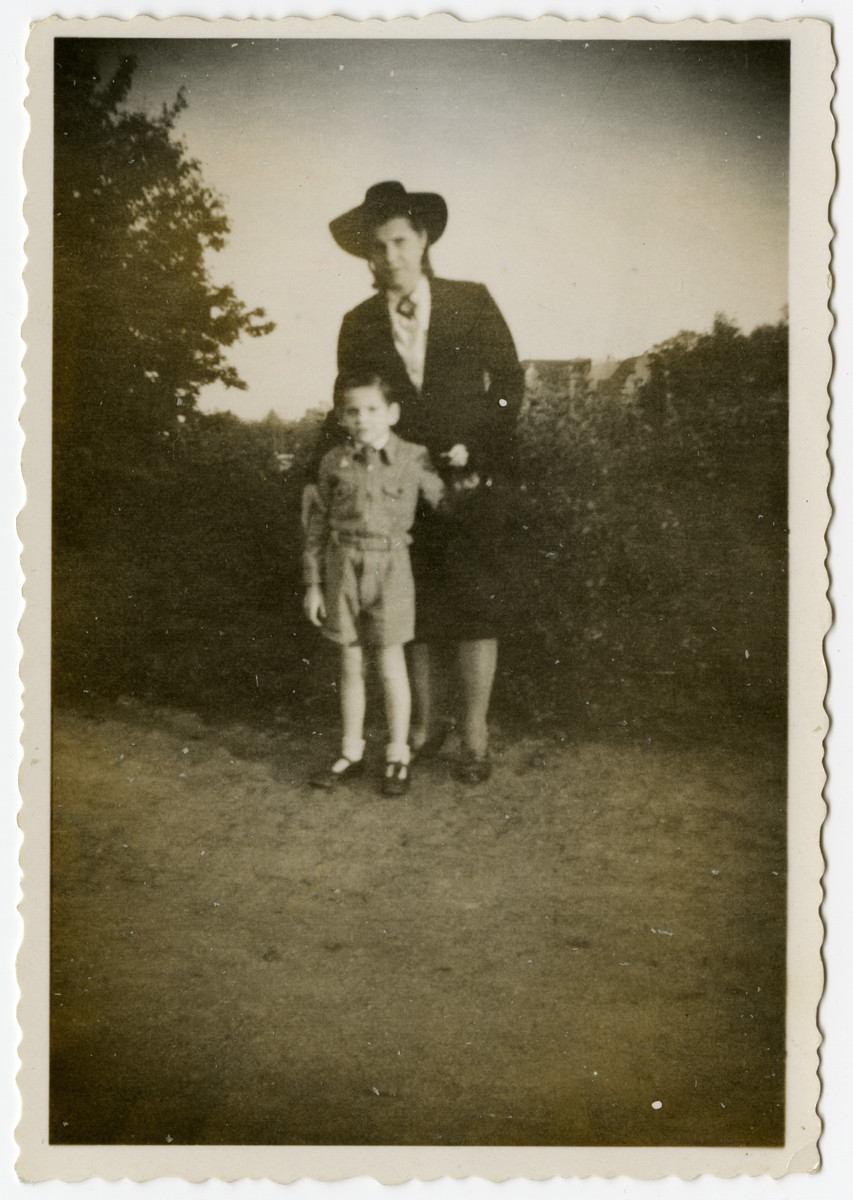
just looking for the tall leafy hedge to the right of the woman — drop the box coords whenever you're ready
[505,317,787,721]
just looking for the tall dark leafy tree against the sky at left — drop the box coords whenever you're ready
[54,38,274,494]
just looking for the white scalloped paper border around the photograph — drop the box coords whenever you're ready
[16,14,835,1184]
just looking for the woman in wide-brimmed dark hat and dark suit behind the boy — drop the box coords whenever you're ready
[329,175,523,782]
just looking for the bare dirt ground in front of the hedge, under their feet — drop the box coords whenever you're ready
[50,702,786,1146]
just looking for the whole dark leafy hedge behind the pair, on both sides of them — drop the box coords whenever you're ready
[55,319,787,726]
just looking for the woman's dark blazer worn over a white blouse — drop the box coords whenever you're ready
[316,280,524,474]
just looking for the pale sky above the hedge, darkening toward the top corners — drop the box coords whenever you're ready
[103,38,788,419]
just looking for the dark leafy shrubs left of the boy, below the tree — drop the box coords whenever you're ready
[54,413,328,709]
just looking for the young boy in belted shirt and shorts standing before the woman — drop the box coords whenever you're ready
[304,373,443,796]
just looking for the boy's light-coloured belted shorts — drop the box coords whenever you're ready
[323,544,415,646]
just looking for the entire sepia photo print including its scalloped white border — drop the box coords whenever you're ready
[18,18,831,1181]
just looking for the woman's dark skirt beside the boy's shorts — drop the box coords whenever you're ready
[412,485,511,642]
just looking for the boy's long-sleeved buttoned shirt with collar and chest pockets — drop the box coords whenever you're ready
[302,433,444,584]
